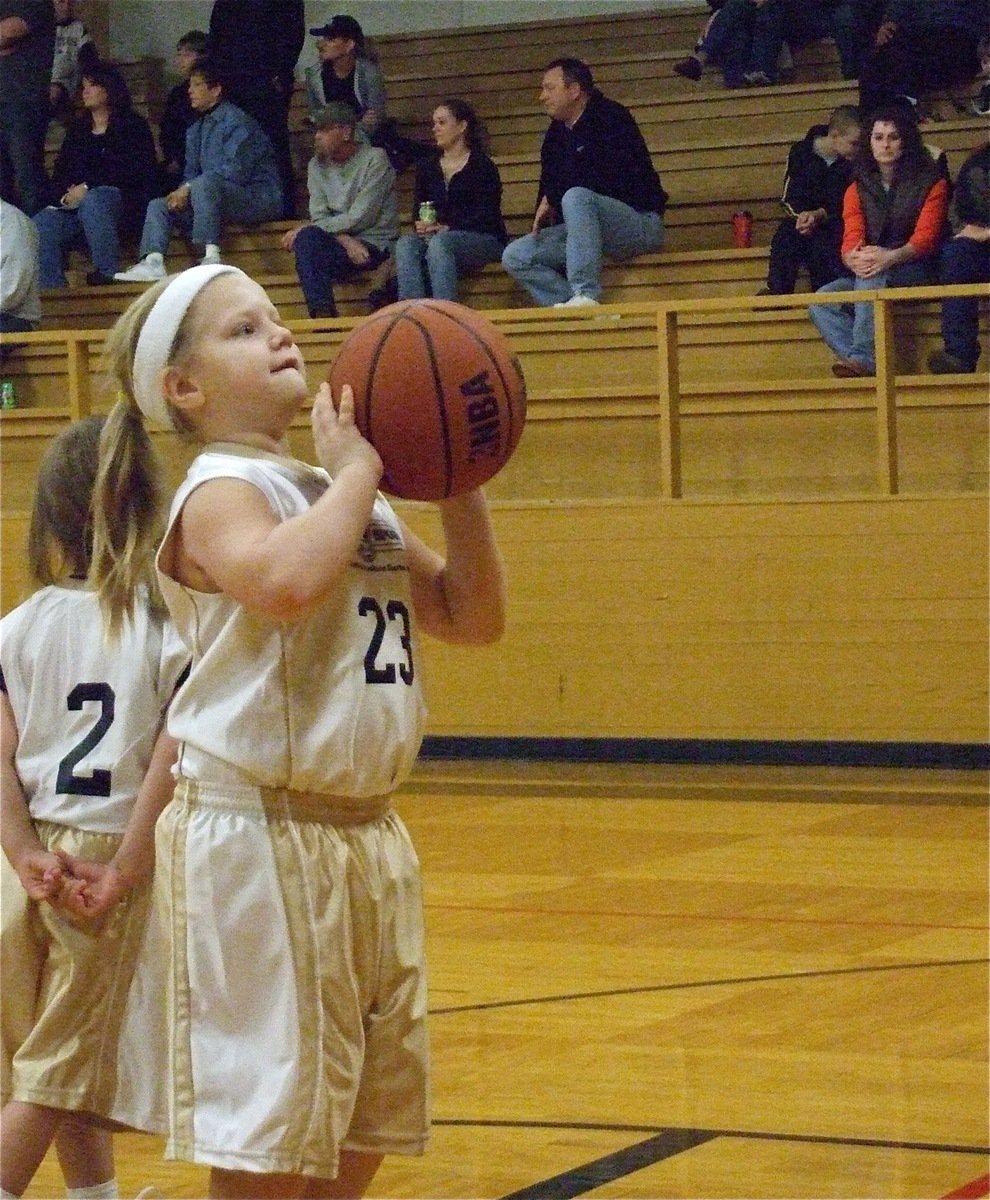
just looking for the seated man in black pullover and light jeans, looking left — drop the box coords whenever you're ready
[502,59,667,308]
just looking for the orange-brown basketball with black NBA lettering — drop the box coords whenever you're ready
[330,300,526,500]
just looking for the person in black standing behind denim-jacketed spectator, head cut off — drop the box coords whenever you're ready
[210,0,306,218]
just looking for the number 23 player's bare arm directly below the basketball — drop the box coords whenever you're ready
[403,488,506,646]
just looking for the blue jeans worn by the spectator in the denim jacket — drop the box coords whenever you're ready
[140,174,282,258]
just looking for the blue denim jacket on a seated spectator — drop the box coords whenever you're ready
[182,100,282,209]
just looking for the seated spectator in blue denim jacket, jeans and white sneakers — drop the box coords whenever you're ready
[114,61,282,283]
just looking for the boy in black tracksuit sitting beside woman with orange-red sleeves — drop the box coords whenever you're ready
[757,104,860,296]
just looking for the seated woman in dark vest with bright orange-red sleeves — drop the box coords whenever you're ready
[808,104,949,378]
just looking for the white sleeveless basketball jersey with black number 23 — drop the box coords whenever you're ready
[158,444,426,797]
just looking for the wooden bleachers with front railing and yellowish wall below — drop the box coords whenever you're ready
[0,6,990,743]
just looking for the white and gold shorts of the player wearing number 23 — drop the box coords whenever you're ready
[155,780,430,1178]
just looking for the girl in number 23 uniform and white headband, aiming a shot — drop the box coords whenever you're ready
[96,265,505,1198]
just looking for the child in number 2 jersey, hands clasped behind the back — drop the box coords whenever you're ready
[0,418,187,1198]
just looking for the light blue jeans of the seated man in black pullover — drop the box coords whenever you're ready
[502,187,664,307]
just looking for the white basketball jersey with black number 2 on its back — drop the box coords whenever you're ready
[0,584,188,833]
